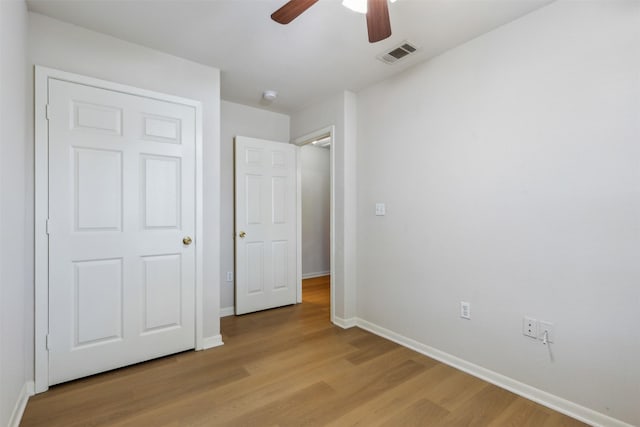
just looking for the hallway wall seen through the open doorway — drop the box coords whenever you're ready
[300,144,331,279]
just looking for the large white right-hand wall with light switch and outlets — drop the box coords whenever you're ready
[357,1,640,425]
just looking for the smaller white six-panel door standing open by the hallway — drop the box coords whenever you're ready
[235,136,297,314]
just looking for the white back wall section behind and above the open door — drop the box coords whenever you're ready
[220,101,289,314]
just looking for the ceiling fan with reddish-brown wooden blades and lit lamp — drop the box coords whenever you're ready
[271,0,395,43]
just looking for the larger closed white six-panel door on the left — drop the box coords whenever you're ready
[48,79,195,384]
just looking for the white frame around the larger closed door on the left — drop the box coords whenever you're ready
[34,65,204,393]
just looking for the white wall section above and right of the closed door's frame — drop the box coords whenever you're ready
[28,13,220,337]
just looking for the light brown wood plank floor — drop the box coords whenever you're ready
[21,278,584,427]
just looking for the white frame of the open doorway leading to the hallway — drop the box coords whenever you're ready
[292,125,336,323]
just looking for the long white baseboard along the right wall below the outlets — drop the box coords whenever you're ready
[358,318,633,427]
